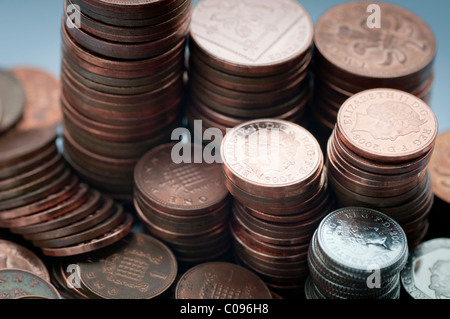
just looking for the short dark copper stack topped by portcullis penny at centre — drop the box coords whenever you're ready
[134,143,231,267]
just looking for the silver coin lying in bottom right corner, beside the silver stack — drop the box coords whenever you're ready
[401,238,450,299]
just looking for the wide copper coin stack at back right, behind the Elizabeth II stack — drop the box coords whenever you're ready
[313,2,436,144]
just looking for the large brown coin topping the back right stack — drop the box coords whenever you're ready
[315,1,436,82]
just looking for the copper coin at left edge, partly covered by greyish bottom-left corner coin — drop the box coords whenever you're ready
[0,240,50,281]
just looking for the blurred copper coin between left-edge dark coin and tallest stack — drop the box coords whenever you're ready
[11,67,62,130]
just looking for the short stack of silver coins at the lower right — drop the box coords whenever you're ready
[305,207,408,299]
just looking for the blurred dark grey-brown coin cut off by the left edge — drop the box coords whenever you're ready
[0,70,26,133]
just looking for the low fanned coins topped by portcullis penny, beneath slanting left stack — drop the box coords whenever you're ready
[50,232,178,299]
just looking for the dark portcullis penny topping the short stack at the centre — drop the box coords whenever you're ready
[134,143,229,215]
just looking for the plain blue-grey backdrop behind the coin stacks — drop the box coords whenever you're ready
[0,0,450,132]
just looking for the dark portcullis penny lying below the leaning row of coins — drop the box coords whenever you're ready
[77,233,178,299]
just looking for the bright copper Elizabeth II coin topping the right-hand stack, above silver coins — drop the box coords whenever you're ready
[337,89,438,163]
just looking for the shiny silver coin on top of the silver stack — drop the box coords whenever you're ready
[317,207,408,277]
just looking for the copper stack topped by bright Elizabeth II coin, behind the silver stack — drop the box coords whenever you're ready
[326,89,438,247]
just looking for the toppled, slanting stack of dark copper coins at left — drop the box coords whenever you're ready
[0,127,133,256]
